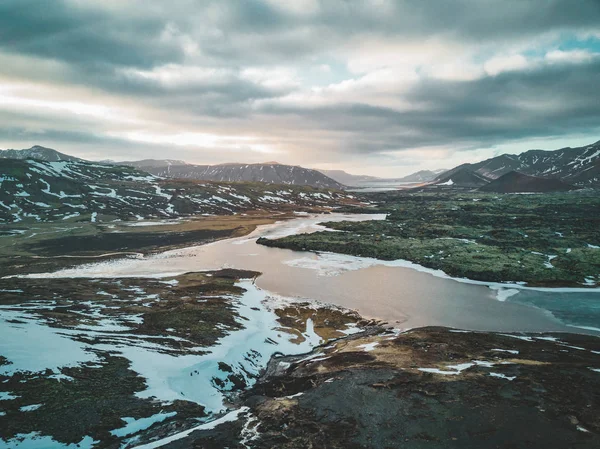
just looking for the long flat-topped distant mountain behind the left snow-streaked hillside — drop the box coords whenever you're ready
[121,161,344,189]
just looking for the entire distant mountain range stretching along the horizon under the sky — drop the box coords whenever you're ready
[0,141,600,191]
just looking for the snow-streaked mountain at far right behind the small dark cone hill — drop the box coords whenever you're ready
[436,141,600,187]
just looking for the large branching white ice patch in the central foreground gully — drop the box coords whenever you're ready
[96,280,321,413]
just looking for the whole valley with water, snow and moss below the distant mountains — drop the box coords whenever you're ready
[0,145,600,449]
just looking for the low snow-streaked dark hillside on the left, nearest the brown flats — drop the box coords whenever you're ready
[0,159,354,223]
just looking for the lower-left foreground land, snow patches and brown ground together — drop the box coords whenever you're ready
[0,270,366,448]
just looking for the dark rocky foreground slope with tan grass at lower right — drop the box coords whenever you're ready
[142,328,600,449]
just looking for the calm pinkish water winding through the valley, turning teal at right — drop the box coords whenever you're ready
[45,214,600,333]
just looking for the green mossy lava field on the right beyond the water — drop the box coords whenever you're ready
[258,191,600,287]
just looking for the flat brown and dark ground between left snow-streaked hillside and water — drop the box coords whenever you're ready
[0,211,286,277]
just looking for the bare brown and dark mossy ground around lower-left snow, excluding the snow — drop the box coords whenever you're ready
[0,269,364,448]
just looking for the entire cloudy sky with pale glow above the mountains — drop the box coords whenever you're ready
[0,0,600,177]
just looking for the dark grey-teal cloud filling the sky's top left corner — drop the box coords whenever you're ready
[0,0,183,70]
